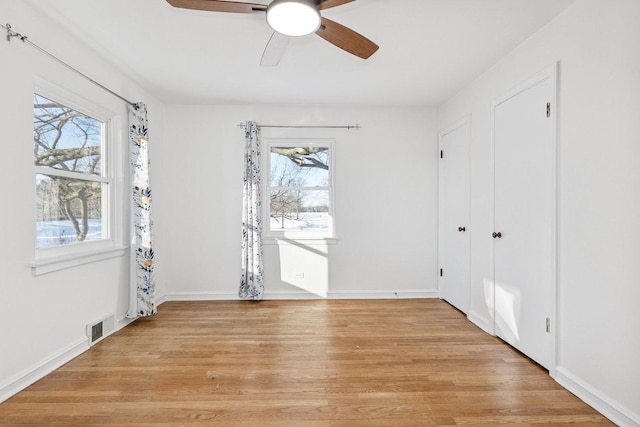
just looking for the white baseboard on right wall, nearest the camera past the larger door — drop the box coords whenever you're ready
[553,367,640,427]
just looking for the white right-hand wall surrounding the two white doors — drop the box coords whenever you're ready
[439,0,640,425]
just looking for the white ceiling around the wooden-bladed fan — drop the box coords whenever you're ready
[28,0,574,106]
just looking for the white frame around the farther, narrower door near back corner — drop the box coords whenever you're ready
[437,114,473,317]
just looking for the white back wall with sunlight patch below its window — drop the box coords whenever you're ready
[153,105,437,299]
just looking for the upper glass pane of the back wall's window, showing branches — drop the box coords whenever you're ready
[270,147,330,187]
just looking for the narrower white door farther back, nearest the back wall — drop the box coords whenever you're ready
[438,119,470,313]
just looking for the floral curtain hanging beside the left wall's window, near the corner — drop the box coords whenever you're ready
[127,103,157,317]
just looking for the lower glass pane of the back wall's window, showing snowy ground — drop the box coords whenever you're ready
[269,190,329,231]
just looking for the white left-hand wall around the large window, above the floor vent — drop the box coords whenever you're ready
[0,0,161,401]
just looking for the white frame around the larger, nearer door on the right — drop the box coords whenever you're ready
[486,62,559,377]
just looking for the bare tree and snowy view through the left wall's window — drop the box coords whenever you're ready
[33,94,107,248]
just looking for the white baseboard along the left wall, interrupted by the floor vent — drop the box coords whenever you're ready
[0,318,136,403]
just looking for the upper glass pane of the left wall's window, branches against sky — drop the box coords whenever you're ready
[33,94,102,175]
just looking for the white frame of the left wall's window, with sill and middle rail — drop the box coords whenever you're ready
[31,78,126,276]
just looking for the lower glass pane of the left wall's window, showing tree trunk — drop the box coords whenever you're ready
[36,174,107,248]
